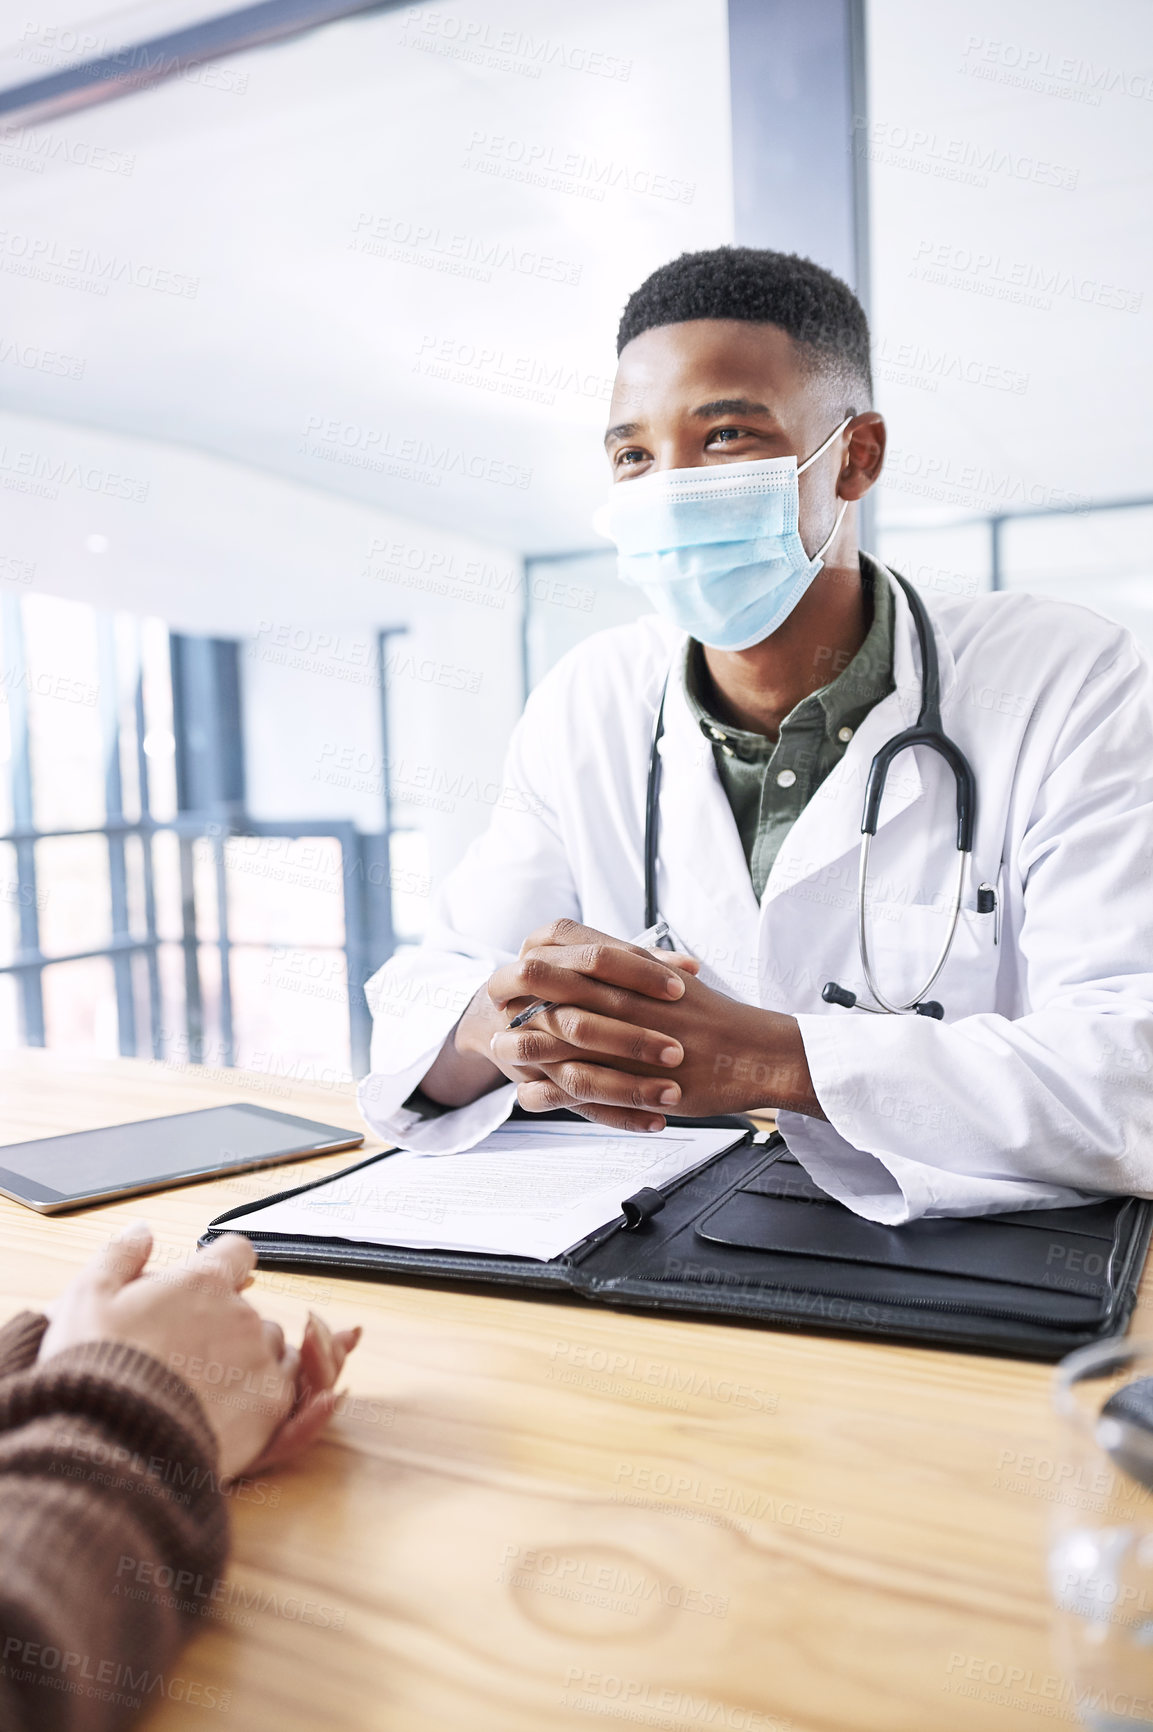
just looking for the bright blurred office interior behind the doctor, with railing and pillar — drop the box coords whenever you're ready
[0,0,1153,1080]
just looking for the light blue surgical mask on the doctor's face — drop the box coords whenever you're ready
[594,416,852,650]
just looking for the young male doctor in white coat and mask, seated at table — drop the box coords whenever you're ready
[360,248,1153,1223]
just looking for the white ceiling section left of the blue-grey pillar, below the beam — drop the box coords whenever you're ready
[0,0,731,549]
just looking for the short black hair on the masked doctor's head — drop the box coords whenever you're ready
[616,246,873,407]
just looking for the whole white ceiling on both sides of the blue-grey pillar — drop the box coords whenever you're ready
[0,0,1153,595]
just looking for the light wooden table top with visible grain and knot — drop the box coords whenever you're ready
[0,1051,1153,1732]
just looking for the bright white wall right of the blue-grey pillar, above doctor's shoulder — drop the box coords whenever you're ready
[857,0,1153,648]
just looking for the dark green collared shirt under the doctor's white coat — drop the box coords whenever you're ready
[684,554,895,901]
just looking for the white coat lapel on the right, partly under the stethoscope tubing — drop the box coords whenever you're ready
[762,584,956,906]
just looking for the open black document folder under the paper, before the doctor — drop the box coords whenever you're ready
[201,1121,1153,1360]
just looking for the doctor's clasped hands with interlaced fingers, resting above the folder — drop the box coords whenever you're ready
[455,920,824,1131]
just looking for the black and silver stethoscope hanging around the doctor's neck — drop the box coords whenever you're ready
[644,572,994,1022]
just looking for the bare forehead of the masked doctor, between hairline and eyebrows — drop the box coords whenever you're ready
[609,319,803,430]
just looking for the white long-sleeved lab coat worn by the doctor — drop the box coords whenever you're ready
[360,587,1153,1223]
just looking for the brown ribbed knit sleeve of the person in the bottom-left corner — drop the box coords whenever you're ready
[0,1311,227,1732]
